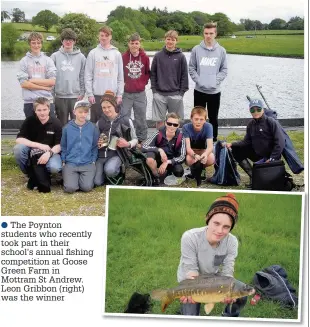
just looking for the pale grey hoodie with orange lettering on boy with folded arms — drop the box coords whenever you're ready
[17,52,56,103]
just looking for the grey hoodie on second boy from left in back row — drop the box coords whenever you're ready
[51,47,86,99]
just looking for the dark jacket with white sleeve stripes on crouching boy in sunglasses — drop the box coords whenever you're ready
[143,126,186,166]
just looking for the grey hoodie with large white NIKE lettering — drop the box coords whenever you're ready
[188,41,227,94]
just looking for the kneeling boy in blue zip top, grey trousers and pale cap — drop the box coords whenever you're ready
[61,100,99,193]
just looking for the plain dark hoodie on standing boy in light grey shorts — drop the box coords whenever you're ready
[151,47,188,96]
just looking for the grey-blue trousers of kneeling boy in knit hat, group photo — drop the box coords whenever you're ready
[95,156,122,186]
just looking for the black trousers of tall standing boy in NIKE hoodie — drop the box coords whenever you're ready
[194,90,221,142]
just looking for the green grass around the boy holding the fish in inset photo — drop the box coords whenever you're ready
[105,189,301,319]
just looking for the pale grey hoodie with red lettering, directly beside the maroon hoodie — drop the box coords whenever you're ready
[85,44,124,97]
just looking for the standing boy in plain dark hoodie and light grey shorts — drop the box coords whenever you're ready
[151,30,188,128]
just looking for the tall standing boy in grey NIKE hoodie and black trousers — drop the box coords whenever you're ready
[188,23,227,142]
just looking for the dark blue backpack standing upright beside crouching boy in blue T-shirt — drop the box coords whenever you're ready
[210,141,240,186]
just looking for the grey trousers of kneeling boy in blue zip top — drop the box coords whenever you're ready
[62,163,96,193]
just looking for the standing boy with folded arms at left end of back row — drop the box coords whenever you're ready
[17,32,56,118]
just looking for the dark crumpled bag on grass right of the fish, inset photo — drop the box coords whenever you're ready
[253,265,298,308]
